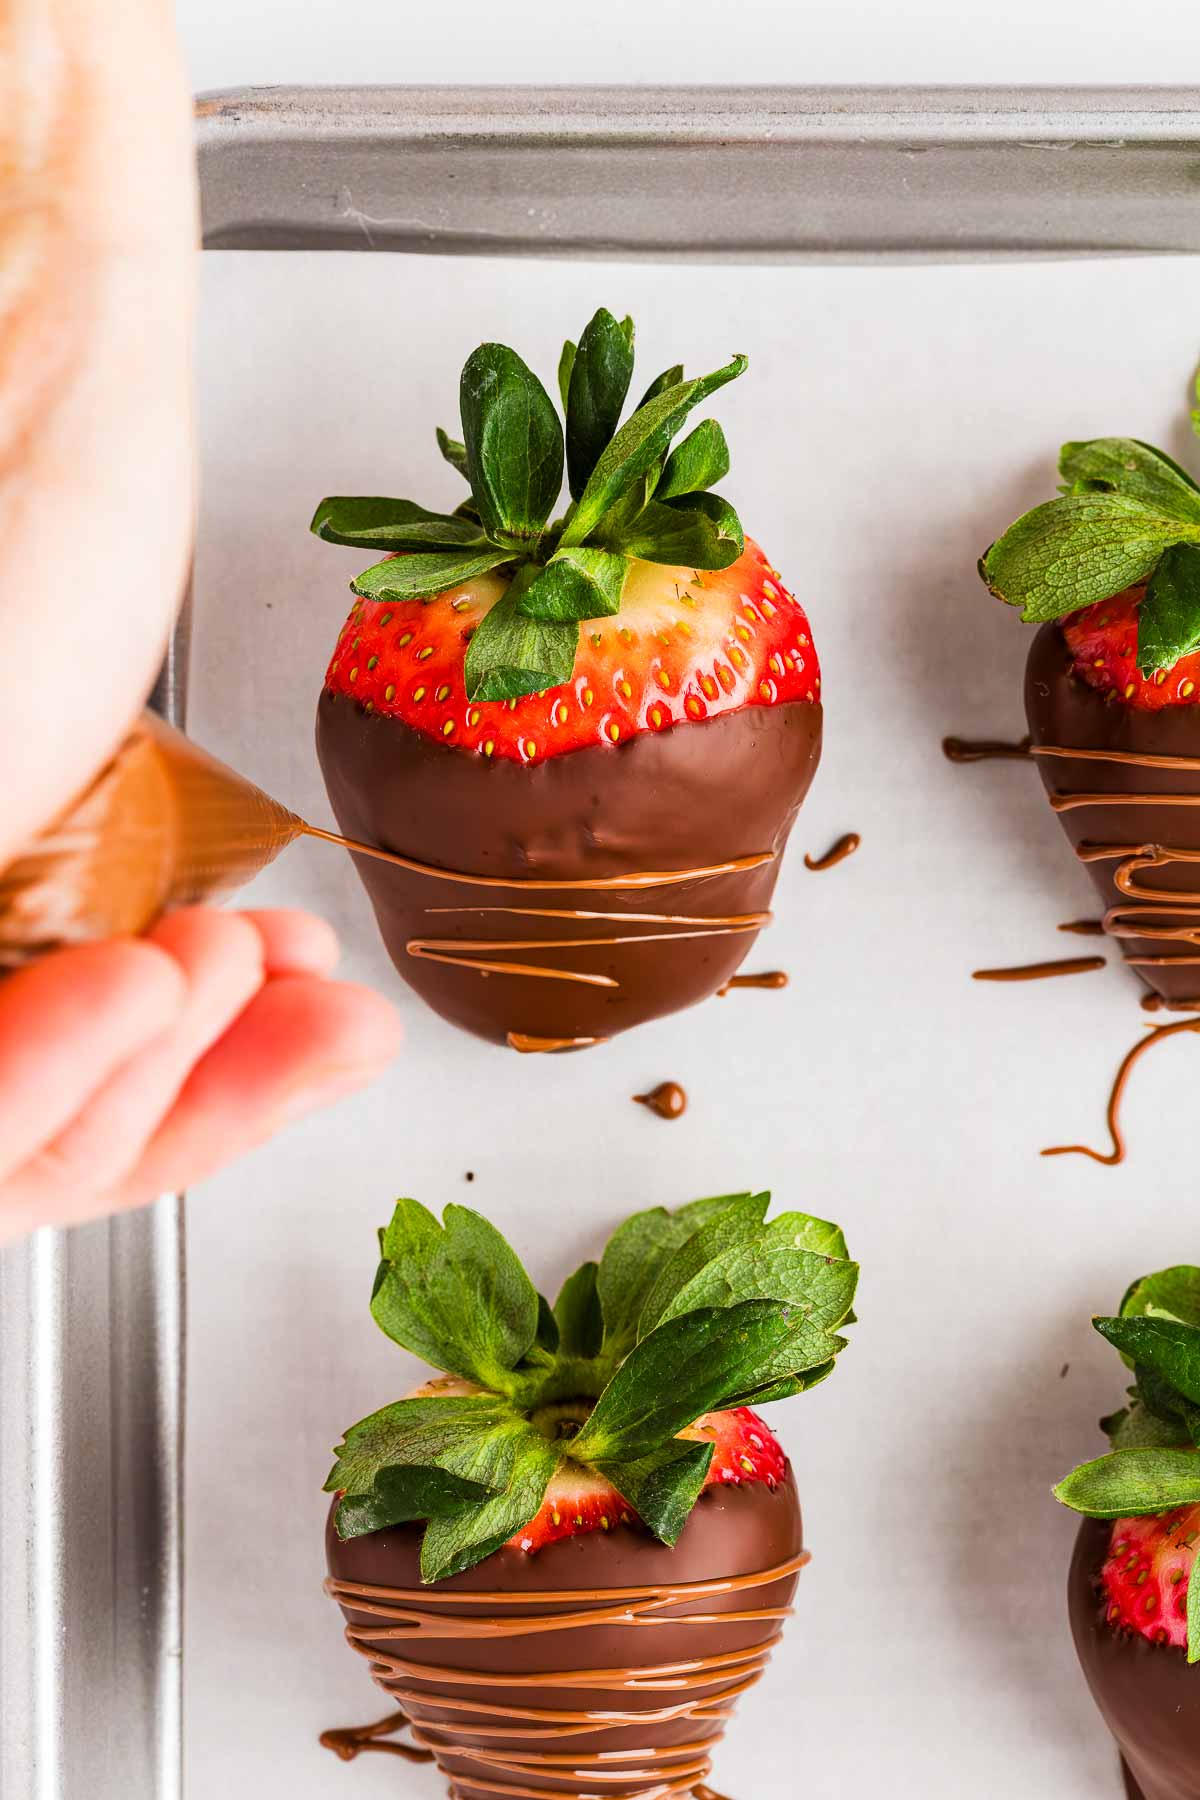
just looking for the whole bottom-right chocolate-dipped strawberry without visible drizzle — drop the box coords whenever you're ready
[1054,1265,1200,1800]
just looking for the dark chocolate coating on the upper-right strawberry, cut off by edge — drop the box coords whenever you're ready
[1025,625,1200,1004]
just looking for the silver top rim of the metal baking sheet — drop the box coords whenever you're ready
[200,88,1200,259]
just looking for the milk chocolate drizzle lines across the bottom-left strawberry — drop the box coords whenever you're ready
[320,1552,810,1800]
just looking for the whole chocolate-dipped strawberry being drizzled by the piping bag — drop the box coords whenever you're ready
[313,310,820,1049]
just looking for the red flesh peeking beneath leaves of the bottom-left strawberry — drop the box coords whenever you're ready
[511,1406,788,1552]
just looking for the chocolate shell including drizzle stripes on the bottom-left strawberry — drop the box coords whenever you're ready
[326,1474,808,1800]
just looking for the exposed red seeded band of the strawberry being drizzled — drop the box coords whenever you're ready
[326,540,820,763]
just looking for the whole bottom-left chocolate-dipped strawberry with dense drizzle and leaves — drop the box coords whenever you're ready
[324,1193,858,1800]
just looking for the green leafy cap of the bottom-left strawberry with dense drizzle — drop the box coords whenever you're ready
[326,1193,856,1580]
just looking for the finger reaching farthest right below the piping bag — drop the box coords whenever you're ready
[113,976,399,1206]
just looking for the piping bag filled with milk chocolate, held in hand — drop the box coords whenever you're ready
[0,713,332,972]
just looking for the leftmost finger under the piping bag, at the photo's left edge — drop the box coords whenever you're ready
[0,938,187,1181]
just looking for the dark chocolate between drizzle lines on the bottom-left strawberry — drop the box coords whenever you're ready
[326,1469,802,1800]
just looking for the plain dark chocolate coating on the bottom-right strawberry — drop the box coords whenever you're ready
[1069,1519,1200,1800]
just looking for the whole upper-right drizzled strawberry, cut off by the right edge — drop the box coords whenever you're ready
[981,421,1200,1012]
